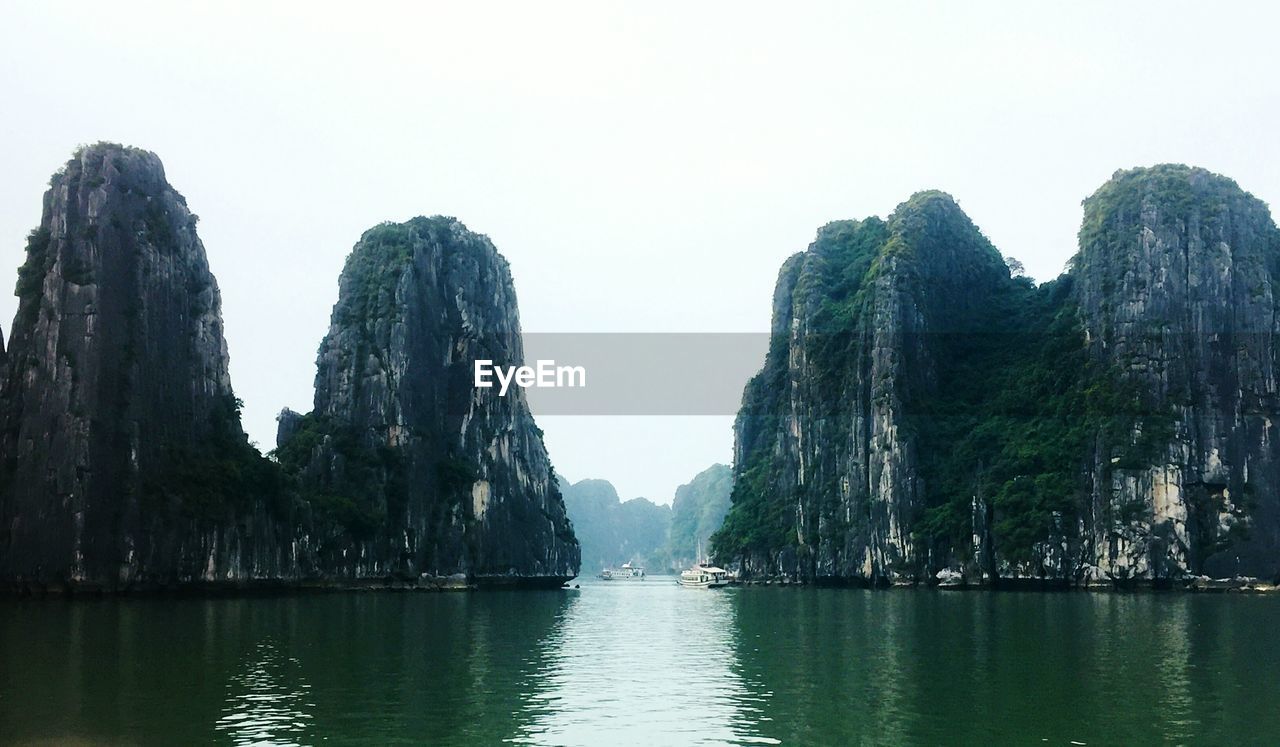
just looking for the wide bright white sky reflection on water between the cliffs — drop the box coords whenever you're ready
[511,578,777,744]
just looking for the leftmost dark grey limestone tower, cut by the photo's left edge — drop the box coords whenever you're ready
[0,145,291,588]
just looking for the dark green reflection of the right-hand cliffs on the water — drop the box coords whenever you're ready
[736,590,1280,744]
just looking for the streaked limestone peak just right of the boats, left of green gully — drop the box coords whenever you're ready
[716,192,1009,581]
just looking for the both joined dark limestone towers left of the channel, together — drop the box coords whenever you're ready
[0,143,577,591]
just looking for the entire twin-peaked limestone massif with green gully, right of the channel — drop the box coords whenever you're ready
[716,166,1280,583]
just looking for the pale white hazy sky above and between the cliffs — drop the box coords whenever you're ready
[0,0,1280,501]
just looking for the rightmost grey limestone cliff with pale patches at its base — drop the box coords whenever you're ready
[1074,166,1280,578]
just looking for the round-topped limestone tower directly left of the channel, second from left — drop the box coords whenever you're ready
[276,217,579,585]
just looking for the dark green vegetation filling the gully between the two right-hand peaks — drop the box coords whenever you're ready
[913,276,1172,562]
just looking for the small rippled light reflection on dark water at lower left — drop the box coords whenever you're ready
[214,641,315,744]
